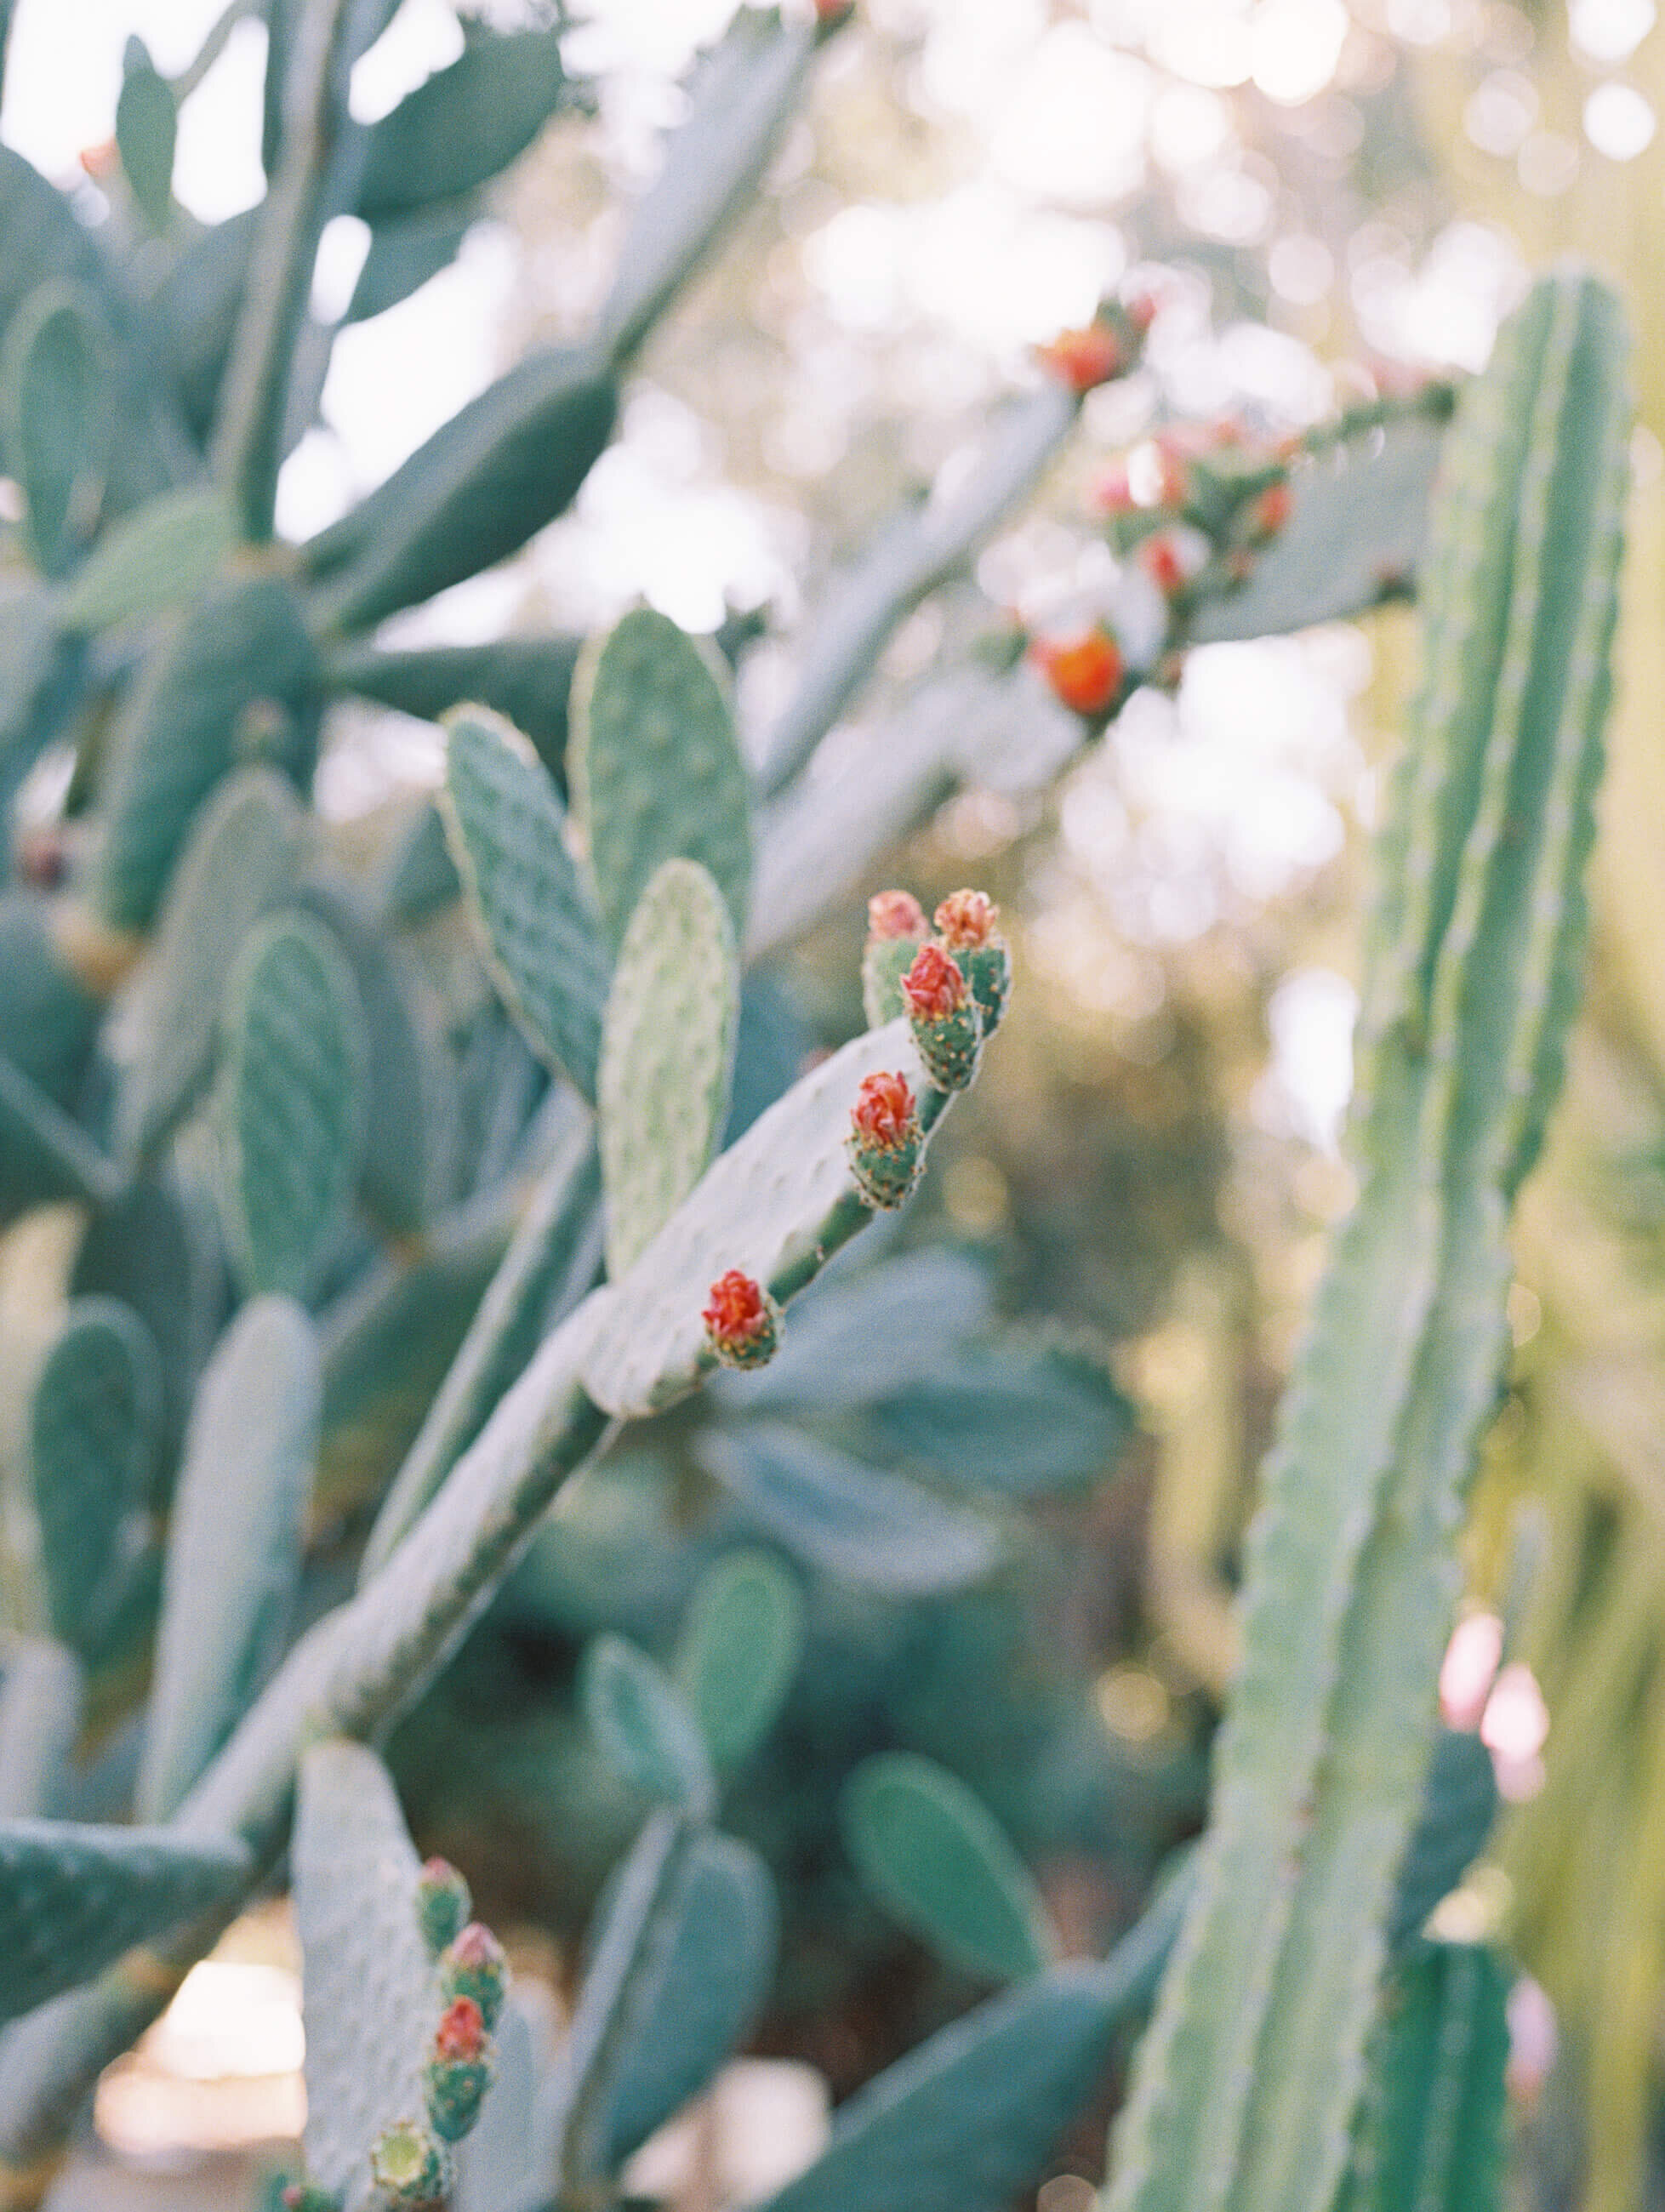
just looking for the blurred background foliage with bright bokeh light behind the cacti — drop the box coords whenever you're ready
[0,0,1665,2212]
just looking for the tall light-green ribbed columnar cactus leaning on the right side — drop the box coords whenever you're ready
[1108,272,1628,2212]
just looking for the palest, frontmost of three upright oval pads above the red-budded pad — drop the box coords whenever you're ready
[597,860,741,1280]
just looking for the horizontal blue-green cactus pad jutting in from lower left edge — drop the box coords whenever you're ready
[0,1821,250,2020]
